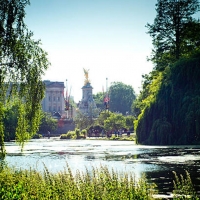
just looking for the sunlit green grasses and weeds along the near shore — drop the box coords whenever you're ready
[0,163,199,200]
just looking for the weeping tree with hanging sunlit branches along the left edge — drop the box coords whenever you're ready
[0,0,49,157]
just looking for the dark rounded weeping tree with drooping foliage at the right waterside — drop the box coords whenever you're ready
[134,55,200,145]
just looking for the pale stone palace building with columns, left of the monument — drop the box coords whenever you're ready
[42,80,65,115]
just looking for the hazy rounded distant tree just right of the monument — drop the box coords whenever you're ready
[109,82,136,115]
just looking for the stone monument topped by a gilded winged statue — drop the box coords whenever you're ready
[78,68,98,117]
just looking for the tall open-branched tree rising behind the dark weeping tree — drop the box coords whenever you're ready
[147,0,200,71]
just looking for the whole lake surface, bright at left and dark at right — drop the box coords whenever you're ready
[5,138,200,195]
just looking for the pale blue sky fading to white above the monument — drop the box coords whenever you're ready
[25,0,157,102]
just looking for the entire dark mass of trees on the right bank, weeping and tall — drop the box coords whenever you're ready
[135,0,200,145]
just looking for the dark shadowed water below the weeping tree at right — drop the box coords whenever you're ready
[140,146,200,194]
